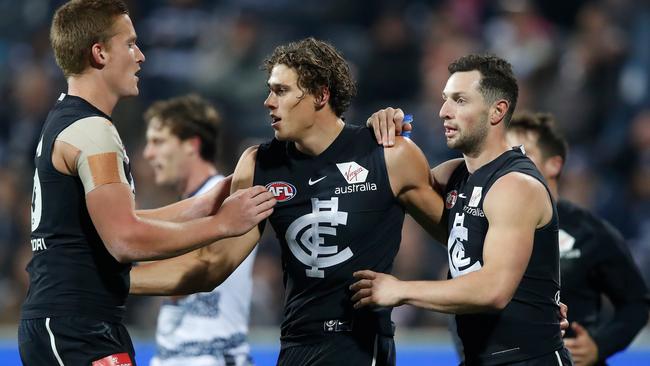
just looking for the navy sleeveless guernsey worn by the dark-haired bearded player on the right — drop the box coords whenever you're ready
[445,148,563,365]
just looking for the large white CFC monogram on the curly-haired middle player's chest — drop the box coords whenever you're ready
[285,197,352,278]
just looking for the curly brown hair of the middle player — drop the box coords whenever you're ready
[262,37,357,117]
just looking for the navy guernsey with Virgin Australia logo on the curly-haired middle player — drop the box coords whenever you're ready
[254,126,404,347]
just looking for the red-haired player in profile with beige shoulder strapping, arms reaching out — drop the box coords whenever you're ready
[18,0,274,366]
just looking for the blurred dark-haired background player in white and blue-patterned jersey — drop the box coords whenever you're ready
[143,94,255,366]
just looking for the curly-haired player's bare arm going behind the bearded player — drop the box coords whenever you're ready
[384,136,445,242]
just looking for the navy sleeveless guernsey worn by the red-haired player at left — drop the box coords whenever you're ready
[21,95,131,322]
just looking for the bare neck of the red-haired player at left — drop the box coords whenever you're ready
[68,72,119,116]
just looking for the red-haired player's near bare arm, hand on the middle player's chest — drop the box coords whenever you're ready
[86,184,268,262]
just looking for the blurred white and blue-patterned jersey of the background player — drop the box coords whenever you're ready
[151,175,255,366]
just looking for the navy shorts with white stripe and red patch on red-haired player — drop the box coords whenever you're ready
[18,317,135,366]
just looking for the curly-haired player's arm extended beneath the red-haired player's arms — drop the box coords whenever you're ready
[130,148,260,295]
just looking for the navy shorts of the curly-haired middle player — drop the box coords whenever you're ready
[278,332,395,366]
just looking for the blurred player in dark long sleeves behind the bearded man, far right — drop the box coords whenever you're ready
[507,113,649,366]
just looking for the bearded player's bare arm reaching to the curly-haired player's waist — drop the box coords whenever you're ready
[352,173,552,314]
